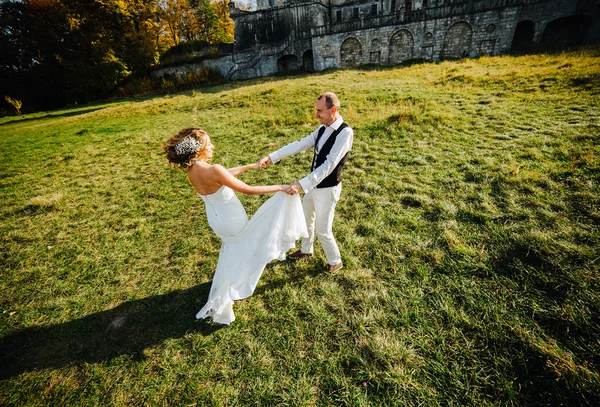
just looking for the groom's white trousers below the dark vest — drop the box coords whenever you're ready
[301,183,342,265]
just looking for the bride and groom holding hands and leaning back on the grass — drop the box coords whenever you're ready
[165,92,353,324]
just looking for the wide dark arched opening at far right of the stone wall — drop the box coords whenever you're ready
[540,15,593,47]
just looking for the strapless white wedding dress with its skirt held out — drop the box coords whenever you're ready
[196,185,308,325]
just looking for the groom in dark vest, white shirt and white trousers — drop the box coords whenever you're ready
[259,92,354,272]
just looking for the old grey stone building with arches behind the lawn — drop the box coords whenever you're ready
[156,0,600,79]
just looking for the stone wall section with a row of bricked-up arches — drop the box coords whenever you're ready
[313,8,519,70]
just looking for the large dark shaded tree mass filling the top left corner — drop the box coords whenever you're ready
[0,0,158,108]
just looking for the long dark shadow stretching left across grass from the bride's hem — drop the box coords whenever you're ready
[0,283,223,379]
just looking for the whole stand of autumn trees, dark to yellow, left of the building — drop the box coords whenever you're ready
[0,0,233,110]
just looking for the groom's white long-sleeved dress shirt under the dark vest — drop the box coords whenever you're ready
[269,116,354,192]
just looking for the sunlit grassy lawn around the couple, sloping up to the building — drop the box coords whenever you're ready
[0,47,600,406]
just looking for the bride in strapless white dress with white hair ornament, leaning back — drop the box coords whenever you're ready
[164,128,308,325]
